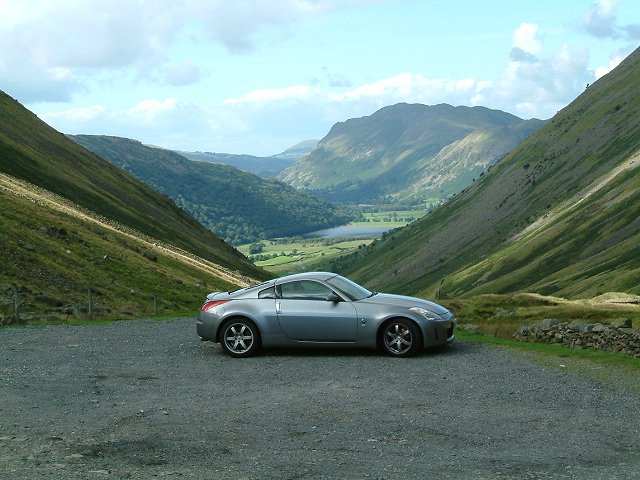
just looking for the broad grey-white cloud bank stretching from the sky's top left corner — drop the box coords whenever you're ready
[0,0,364,103]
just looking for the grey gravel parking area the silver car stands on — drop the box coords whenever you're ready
[0,318,640,480]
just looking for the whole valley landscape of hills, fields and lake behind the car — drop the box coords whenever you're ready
[0,45,640,360]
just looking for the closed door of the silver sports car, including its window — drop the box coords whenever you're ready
[276,280,358,342]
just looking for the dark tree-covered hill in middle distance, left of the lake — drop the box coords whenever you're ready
[70,135,352,244]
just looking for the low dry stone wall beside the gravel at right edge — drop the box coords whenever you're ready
[514,319,640,357]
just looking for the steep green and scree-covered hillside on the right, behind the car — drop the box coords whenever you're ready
[336,49,640,298]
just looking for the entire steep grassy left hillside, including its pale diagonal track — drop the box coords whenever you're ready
[0,92,270,323]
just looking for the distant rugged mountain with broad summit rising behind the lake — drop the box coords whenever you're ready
[278,103,543,204]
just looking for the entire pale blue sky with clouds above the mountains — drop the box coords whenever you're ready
[0,0,640,156]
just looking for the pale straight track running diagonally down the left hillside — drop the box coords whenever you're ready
[0,173,258,286]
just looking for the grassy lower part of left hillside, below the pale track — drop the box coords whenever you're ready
[0,189,240,324]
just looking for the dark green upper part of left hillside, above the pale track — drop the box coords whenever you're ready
[0,92,268,278]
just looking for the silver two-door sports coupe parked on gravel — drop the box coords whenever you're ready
[197,272,456,357]
